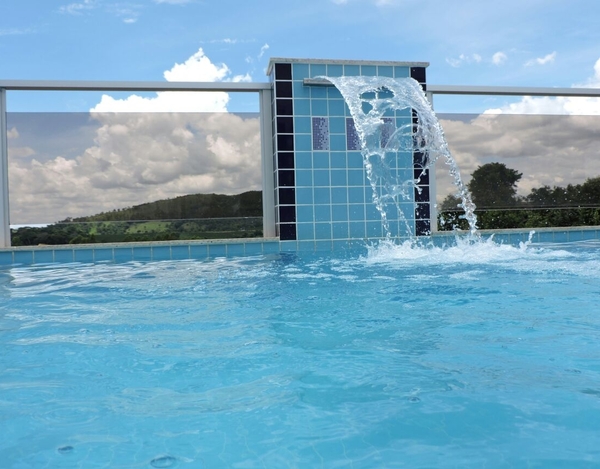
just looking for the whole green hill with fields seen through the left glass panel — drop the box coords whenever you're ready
[11,191,262,246]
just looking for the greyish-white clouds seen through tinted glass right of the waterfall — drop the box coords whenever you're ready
[436,115,600,201]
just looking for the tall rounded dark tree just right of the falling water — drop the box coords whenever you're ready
[467,163,523,209]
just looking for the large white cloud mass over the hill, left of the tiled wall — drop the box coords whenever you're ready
[9,49,261,224]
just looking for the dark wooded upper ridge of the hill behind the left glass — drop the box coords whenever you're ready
[59,191,262,223]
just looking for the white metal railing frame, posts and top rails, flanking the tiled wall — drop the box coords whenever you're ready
[0,78,600,248]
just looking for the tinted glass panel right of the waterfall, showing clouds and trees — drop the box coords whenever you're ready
[436,114,600,230]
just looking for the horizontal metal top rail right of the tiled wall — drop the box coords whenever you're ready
[304,78,600,97]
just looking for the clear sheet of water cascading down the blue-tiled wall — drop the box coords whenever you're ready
[319,76,479,240]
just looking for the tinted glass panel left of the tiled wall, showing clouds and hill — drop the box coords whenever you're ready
[7,112,262,245]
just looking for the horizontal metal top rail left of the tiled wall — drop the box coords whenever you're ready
[0,80,271,93]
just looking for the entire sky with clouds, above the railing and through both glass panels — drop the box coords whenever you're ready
[0,0,600,223]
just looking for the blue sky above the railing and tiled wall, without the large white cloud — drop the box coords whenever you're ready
[0,0,600,111]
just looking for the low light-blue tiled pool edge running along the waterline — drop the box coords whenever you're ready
[0,227,600,267]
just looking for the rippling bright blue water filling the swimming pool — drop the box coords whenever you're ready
[0,241,600,468]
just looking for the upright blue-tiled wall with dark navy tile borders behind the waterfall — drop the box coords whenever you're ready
[267,58,432,250]
